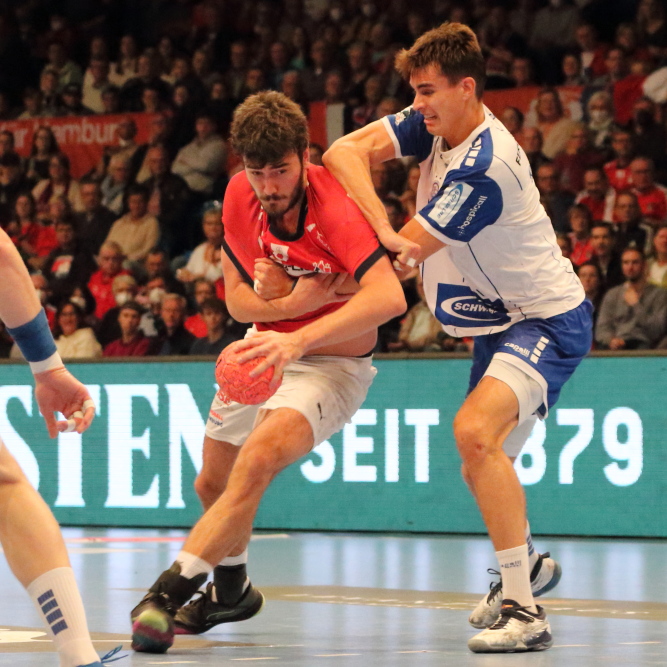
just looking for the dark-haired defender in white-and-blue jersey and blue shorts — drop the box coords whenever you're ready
[324,23,592,652]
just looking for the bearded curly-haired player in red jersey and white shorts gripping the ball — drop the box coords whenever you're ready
[131,92,406,652]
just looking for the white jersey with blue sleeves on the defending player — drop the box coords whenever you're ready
[383,107,585,337]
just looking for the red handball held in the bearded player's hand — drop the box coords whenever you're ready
[215,341,278,405]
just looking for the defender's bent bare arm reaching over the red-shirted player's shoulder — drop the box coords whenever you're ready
[322,120,417,263]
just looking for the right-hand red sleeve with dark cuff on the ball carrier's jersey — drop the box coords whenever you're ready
[308,167,386,282]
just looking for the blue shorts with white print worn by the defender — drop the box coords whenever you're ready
[468,299,593,417]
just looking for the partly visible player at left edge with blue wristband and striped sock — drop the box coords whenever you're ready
[0,229,117,667]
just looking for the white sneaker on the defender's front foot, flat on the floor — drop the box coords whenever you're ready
[468,600,553,653]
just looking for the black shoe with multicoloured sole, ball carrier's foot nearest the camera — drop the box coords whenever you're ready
[130,563,207,653]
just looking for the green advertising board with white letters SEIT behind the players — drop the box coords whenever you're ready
[0,357,667,537]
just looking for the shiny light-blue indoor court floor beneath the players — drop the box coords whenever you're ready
[0,528,667,667]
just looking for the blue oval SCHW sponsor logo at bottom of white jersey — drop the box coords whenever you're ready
[435,283,510,327]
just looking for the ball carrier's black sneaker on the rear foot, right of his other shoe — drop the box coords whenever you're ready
[174,582,264,635]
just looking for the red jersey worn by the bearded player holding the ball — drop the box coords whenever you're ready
[222,165,385,331]
